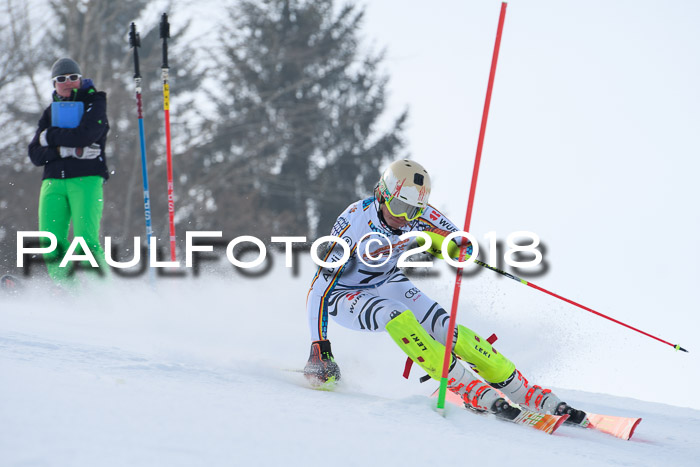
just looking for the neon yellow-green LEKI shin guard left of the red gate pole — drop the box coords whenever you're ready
[386,310,445,380]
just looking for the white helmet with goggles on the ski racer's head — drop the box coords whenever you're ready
[375,159,430,221]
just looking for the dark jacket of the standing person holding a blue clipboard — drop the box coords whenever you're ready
[29,79,109,180]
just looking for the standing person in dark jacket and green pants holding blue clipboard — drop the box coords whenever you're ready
[29,58,109,285]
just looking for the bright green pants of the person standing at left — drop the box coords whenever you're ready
[39,175,109,285]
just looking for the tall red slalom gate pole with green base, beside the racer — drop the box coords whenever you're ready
[437,2,508,413]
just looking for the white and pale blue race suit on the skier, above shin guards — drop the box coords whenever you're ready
[306,197,461,344]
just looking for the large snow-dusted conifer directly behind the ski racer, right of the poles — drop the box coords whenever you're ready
[191,0,407,235]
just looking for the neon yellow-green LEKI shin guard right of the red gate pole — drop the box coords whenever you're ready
[455,325,515,383]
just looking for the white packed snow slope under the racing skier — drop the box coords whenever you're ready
[0,261,700,466]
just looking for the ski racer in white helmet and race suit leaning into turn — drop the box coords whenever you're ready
[304,160,586,424]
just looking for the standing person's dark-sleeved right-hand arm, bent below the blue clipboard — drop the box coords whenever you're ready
[41,93,107,148]
